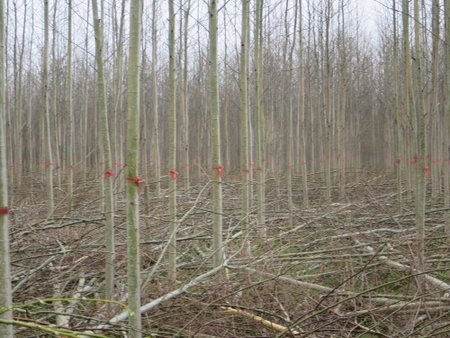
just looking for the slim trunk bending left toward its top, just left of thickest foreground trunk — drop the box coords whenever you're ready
[92,0,115,299]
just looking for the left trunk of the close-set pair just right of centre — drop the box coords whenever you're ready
[239,0,253,256]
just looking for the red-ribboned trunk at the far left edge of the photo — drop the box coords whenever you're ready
[0,0,13,332]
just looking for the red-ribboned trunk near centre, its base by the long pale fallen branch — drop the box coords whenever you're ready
[208,0,224,267]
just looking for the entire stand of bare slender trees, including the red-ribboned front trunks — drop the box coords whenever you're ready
[0,0,450,336]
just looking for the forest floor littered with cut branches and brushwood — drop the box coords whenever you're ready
[6,173,450,338]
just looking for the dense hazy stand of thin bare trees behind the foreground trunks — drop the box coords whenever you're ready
[0,1,447,203]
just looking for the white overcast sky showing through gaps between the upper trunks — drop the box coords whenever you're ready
[6,0,388,66]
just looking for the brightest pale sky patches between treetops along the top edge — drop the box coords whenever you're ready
[3,0,387,68]
